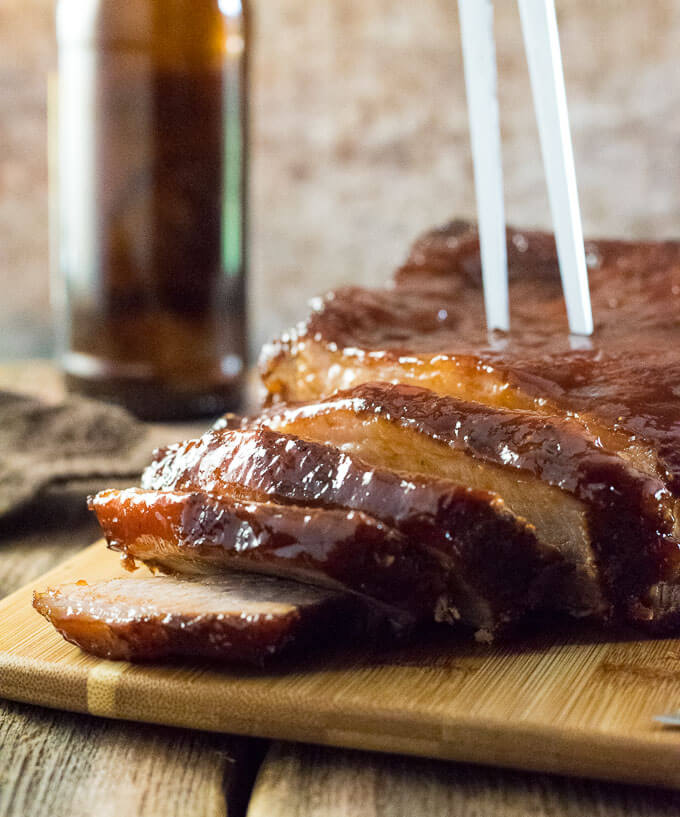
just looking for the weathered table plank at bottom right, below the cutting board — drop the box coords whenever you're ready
[248,743,680,817]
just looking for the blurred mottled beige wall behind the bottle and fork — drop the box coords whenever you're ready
[0,0,680,358]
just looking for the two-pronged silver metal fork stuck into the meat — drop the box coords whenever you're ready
[458,0,593,335]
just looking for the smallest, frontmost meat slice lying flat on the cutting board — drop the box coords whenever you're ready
[33,574,356,664]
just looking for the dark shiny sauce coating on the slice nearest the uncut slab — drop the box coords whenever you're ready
[241,383,680,619]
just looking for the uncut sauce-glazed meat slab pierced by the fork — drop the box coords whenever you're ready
[262,222,680,495]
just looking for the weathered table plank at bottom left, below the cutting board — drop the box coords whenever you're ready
[0,704,256,817]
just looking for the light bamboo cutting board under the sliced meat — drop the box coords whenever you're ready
[0,543,680,788]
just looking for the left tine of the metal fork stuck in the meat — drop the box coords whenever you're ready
[458,0,510,332]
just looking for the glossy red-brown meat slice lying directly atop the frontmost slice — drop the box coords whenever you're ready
[90,488,432,626]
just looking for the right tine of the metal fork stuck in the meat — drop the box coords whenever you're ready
[518,0,593,335]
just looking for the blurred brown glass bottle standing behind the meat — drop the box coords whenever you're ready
[54,0,249,420]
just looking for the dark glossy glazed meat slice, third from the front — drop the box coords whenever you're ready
[142,428,566,639]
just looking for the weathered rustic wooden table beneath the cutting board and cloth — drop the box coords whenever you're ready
[0,363,680,817]
